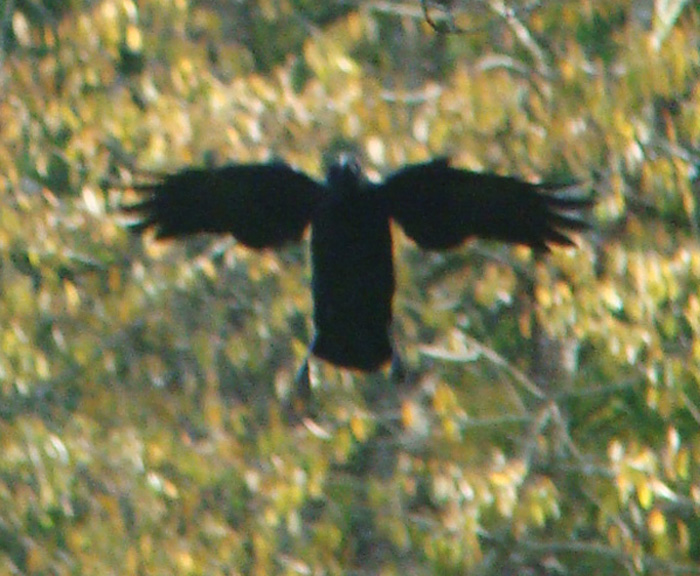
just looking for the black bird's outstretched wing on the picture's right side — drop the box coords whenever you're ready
[378,159,592,250]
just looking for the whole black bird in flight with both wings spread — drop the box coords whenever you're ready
[125,156,591,372]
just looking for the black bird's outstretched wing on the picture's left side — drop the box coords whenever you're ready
[124,162,324,248]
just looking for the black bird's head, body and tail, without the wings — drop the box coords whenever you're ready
[311,164,395,371]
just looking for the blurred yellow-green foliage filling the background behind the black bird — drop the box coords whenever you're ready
[0,0,700,575]
